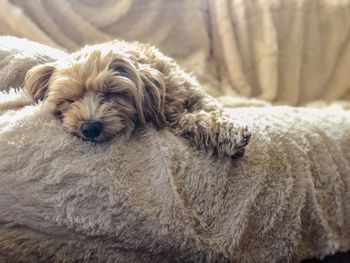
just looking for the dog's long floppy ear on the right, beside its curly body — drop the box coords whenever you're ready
[136,68,166,127]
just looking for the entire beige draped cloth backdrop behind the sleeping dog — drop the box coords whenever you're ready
[0,0,350,105]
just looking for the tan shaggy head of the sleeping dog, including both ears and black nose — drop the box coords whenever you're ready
[24,41,165,142]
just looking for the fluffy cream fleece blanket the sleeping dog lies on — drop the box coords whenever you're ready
[0,37,350,262]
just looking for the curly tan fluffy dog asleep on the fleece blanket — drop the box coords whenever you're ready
[24,41,250,157]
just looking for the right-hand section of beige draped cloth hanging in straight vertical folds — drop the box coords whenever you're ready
[209,0,350,105]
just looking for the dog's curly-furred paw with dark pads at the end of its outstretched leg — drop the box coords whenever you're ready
[217,122,251,159]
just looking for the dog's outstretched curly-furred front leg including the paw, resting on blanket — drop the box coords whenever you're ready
[171,110,250,157]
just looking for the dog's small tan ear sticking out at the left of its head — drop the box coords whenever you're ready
[24,64,55,101]
